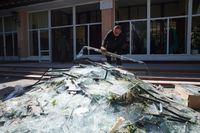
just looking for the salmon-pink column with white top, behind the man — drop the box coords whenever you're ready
[100,0,115,39]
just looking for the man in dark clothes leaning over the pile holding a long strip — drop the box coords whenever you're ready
[101,25,126,65]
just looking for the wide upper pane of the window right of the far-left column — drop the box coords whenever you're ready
[29,11,48,29]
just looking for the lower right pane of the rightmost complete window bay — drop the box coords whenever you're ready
[169,18,187,54]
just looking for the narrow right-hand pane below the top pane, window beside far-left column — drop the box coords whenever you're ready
[40,30,49,50]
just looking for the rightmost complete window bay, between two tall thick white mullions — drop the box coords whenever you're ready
[150,0,188,54]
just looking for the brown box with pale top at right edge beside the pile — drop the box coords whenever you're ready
[175,84,200,109]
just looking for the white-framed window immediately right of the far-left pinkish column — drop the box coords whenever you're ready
[29,11,50,60]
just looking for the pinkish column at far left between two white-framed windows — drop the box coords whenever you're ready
[17,11,29,58]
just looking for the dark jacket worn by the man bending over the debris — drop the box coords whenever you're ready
[102,30,126,54]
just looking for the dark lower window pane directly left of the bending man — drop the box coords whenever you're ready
[89,25,101,54]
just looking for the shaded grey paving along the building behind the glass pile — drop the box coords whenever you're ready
[0,62,200,78]
